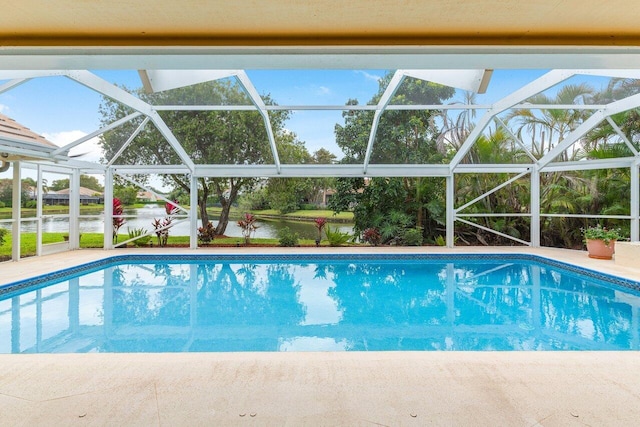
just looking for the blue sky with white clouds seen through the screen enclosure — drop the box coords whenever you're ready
[0,70,606,182]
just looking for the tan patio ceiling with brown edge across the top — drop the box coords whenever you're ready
[0,0,640,46]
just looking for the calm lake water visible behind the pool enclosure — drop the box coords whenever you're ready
[0,205,353,239]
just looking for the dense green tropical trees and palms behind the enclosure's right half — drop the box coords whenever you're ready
[330,73,640,248]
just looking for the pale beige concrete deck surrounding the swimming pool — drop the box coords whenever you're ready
[0,247,640,426]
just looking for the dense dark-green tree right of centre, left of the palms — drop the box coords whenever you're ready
[329,73,454,241]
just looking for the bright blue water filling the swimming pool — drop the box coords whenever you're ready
[0,255,640,353]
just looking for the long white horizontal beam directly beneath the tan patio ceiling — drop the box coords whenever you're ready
[0,45,640,70]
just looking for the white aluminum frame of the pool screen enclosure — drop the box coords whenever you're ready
[0,55,640,259]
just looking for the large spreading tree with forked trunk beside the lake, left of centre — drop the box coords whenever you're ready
[100,80,289,235]
